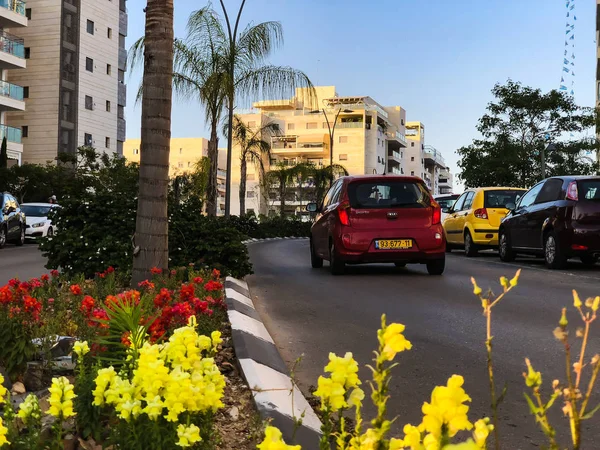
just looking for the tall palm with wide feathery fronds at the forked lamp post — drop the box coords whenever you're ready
[188,0,313,215]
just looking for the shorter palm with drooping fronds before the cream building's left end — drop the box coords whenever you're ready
[229,116,279,216]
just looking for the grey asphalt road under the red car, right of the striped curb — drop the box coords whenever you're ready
[248,240,600,450]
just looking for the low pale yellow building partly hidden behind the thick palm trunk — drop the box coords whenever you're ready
[123,138,227,215]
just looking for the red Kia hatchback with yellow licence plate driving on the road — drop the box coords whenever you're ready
[306,175,446,275]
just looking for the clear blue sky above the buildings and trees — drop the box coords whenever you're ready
[127,0,596,182]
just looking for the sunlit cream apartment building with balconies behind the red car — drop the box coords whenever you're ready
[231,86,407,215]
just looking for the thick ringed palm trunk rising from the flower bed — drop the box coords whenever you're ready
[132,0,173,286]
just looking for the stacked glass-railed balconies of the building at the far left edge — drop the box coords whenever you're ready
[0,0,28,165]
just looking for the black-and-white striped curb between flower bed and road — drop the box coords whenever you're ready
[225,276,321,444]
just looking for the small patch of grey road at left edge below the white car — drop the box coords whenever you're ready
[0,244,48,286]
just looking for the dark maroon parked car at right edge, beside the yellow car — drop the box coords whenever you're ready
[499,176,600,269]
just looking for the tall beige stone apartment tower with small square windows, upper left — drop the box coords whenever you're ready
[0,0,127,163]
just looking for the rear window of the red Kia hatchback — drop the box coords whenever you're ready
[348,180,431,209]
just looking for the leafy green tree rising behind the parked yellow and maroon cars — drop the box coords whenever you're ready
[458,80,597,187]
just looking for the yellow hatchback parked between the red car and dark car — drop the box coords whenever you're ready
[443,187,527,256]
